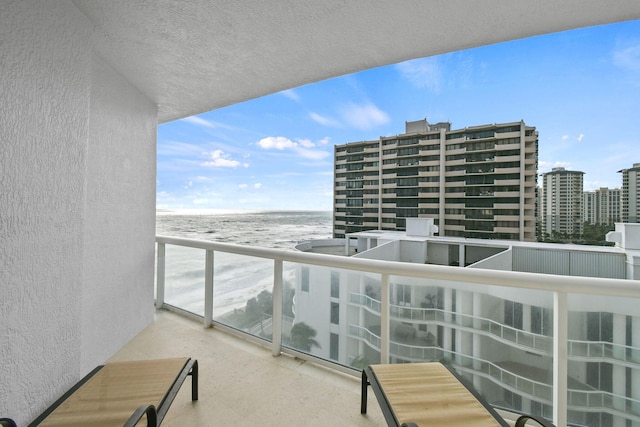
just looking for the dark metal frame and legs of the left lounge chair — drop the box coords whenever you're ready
[29,358,198,427]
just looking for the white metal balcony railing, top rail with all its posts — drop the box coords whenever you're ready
[156,236,640,426]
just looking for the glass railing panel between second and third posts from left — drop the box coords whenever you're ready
[213,251,278,340]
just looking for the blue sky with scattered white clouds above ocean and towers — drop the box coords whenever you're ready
[156,21,640,210]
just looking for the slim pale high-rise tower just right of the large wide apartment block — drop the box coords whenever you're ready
[540,168,584,236]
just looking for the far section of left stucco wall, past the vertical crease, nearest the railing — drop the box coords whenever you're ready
[81,57,157,371]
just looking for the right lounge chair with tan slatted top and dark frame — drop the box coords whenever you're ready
[360,362,553,427]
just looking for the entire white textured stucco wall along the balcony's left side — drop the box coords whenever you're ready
[0,1,155,424]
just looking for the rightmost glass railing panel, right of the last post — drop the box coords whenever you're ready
[567,295,640,427]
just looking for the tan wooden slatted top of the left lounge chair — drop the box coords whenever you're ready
[39,357,190,427]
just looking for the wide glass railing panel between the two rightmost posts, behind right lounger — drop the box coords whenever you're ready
[389,275,553,415]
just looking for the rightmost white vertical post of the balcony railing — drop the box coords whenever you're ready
[553,291,569,426]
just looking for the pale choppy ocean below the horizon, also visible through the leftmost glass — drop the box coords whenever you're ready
[156,210,332,318]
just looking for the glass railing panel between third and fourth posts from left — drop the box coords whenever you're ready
[282,262,381,369]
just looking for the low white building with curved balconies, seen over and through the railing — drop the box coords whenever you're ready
[295,224,640,427]
